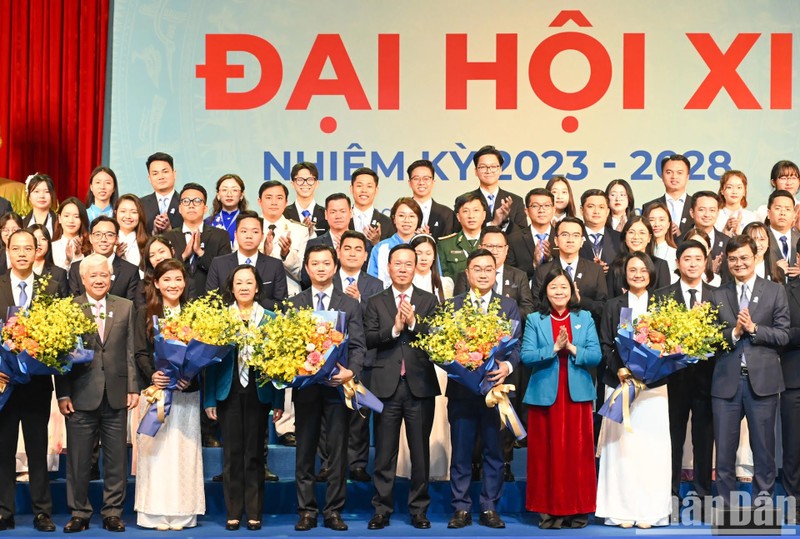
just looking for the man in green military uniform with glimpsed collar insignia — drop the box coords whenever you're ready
[437,192,488,281]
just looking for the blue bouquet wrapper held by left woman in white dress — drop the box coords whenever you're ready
[136,333,228,436]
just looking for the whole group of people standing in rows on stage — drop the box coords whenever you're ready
[0,146,800,532]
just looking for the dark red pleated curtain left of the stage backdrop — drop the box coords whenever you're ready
[0,0,110,200]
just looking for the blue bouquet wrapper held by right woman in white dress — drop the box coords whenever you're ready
[597,307,700,423]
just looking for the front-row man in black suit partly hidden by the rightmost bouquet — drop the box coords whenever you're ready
[654,240,715,499]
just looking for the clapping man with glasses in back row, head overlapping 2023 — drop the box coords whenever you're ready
[472,146,528,234]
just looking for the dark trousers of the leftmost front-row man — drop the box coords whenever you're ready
[0,385,53,518]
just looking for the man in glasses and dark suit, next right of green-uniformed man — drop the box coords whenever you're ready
[507,187,557,280]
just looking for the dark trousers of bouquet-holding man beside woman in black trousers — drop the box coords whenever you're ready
[292,385,349,518]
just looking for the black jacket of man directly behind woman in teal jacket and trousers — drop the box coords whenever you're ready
[206,252,289,312]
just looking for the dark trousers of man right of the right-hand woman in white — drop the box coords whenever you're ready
[667,365,714,496]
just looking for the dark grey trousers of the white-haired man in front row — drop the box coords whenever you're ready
[67,394,128,518]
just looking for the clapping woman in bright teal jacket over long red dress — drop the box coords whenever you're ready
[521,268,602,529]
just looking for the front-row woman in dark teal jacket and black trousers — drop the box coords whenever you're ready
[204,264,284,531]
